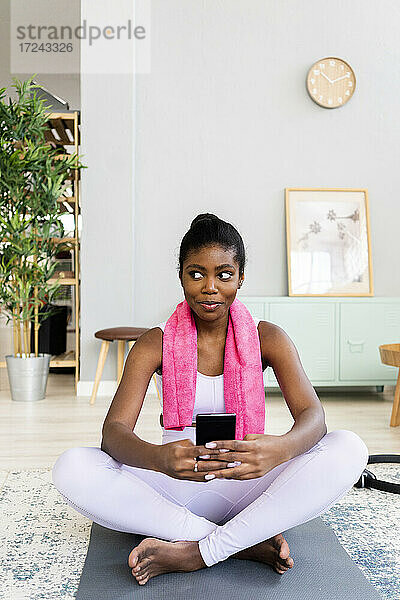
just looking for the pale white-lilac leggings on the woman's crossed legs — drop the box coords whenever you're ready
[52,428,368,567]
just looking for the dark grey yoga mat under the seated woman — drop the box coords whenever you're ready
[76,517,382,600]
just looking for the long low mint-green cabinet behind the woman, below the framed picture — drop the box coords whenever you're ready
[238,296,400,387]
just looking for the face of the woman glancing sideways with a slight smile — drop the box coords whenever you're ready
[180,245,244,321]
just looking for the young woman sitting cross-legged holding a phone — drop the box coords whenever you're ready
[53,213,368,585]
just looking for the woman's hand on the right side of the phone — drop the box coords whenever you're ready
[198,433,288,479]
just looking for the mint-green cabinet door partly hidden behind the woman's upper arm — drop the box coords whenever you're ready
[268,302,335,383]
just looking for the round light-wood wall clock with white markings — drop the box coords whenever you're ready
[307,56,356,108]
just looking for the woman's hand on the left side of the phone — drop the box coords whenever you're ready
[160,439,230,483]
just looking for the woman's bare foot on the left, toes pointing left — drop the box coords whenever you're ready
[128,538,207,585]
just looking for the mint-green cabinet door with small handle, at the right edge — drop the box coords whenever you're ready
[340,303,400,381]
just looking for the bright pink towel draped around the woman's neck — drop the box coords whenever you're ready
[162,298,265,440]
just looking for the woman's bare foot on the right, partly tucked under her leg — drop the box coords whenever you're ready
[231,533,294,574]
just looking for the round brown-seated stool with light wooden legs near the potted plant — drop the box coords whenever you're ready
[90,327,149,404]
